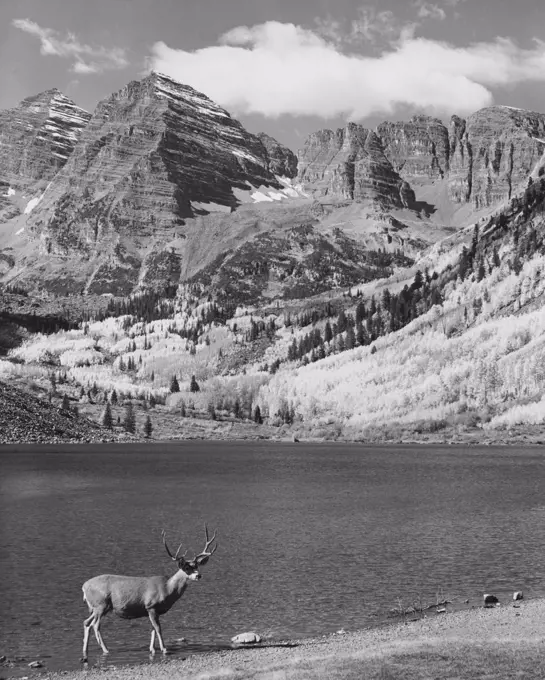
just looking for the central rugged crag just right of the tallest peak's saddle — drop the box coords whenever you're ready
[297,123,410,208]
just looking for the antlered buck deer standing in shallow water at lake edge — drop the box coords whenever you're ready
[82,524,218,662]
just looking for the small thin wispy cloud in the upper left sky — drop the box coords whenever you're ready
[12,19,129,75]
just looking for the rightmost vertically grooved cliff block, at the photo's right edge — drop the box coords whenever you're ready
[448,106,545,208]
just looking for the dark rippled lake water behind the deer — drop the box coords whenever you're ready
[0,441,545,675]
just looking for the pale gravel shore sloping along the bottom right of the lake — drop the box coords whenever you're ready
[42,600,545,680]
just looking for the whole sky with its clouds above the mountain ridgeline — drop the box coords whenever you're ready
[0,0,545,150]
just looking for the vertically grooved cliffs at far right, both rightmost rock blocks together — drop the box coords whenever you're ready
[377,106,545,210]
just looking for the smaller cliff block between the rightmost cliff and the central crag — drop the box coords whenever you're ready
[377,116,449,183]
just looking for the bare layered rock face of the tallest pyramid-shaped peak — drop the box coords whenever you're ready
[29,73,294,258]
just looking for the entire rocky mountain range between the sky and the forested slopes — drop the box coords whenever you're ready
[0,73,545,301]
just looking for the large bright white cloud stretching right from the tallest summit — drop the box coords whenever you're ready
[149,21,545,120]
